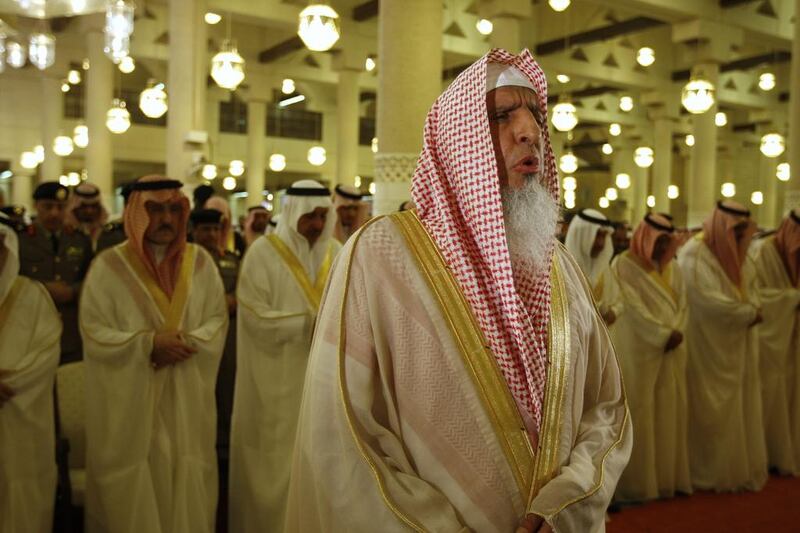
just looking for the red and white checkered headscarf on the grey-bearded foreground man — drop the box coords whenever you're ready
[412,49,559,433]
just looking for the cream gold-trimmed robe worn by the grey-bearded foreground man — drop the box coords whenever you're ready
[285,213,631,533]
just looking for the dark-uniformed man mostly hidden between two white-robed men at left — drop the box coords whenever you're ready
[190,209,240,524]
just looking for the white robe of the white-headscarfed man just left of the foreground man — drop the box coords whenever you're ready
[229,237,340,533]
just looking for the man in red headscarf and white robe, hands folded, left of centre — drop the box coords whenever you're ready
[80,176,228,533]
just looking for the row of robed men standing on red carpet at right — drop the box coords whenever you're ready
[566,201,800,502]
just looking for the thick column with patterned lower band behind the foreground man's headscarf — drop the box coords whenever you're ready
[374,0,442,215]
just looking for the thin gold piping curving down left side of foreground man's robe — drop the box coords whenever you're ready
[338,217,425,533]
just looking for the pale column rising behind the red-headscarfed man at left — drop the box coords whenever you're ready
[167,0,206,181]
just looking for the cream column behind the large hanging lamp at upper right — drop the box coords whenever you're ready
[686,63,719,226]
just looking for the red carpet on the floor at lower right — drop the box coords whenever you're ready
[606,476,800,533]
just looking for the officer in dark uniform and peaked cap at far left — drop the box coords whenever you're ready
[19,181,92,364]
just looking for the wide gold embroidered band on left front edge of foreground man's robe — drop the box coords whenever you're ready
[390,211,534,499]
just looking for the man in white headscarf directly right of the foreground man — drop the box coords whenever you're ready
[564,209,623,326]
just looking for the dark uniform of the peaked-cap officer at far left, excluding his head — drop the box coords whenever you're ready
[19,223,93,364]
